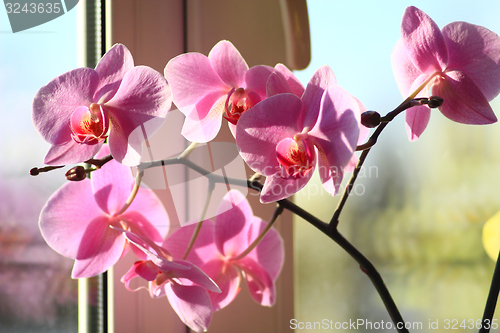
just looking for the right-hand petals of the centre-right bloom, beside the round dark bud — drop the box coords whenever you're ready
[309,85,361,194]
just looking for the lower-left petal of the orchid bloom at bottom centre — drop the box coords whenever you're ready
[202,258,241,311]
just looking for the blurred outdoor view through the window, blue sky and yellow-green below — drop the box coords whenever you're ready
[0,0,500,333]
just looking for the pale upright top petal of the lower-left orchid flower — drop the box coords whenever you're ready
[91,145,134,215]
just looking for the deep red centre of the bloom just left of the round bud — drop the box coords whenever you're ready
[276,130,316,177]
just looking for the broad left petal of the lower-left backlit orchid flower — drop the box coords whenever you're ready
[39,179,101,259]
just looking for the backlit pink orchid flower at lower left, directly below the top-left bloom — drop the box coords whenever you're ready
[39,145,169,278]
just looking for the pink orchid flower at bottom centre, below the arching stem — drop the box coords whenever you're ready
[163,190,284,311]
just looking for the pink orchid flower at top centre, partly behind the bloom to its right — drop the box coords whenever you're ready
[165,40,304,142]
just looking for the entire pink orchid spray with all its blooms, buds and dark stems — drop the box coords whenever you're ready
[27,7,500,332]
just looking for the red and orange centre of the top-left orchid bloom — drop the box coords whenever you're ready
[70,103,109,145]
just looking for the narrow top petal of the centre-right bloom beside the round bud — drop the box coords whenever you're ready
[299,65,337,128]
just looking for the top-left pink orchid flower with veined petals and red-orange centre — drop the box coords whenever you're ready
[32,44,172,166]
